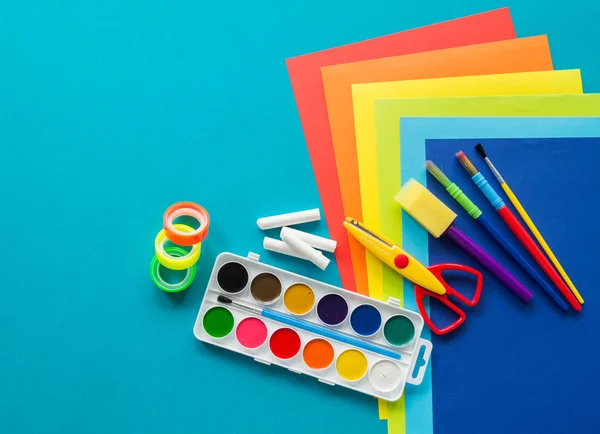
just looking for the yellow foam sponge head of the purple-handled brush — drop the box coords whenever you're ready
[394,179,456,238]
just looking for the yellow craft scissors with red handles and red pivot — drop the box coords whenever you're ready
[344,217,483,335]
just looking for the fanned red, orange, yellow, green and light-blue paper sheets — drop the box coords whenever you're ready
[287,5,600,434]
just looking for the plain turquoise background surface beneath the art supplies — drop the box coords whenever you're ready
[0,0,600,434]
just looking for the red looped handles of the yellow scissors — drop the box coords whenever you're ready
[415,264,483,335]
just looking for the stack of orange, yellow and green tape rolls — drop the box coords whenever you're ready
[150,202,210,292]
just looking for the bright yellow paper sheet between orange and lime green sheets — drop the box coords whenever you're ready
[352,70,582,434]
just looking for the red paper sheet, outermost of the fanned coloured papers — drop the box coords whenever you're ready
[286,8,516,291]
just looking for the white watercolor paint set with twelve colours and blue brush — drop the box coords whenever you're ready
[194,253,432,401]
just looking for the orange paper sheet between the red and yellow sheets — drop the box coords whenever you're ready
[321,36,553,294]
